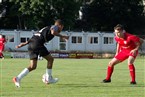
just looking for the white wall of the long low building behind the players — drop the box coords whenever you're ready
[0,30,116,53]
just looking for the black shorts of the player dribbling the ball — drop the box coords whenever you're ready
[28,36,50,59]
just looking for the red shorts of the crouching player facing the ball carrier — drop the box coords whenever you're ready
[115,50,138,61]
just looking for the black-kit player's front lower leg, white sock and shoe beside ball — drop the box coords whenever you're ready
[43,54,58,83]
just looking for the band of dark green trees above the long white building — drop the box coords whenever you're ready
[0,0,145,34]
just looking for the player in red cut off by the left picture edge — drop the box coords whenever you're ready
[0,35,6,58]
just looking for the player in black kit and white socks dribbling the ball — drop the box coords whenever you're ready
[13,20,69,87]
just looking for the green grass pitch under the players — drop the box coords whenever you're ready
[0,58,145,97]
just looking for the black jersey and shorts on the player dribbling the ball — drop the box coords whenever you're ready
[28,25,59,59]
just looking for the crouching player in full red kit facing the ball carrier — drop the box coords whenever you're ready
[103,24,143,84]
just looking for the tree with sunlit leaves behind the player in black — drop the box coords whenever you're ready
[11,0,81,29]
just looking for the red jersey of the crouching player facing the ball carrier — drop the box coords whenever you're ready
[115,32,140,50]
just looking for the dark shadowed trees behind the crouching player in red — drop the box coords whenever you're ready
[85,0,144,31]
